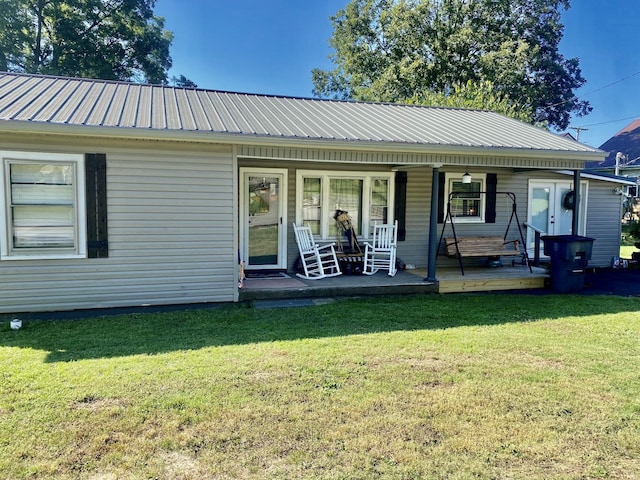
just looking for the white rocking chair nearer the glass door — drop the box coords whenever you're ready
[293,223,342,280]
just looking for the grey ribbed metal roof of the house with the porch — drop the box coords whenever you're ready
[0,72,602,159]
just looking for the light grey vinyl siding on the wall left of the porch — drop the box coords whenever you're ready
[0,146,237,313]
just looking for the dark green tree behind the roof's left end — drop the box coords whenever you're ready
[0,0,173,83]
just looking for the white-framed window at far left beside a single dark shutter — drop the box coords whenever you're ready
[0,152,86,260]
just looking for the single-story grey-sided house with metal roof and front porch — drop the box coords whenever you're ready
[0,73,623,313]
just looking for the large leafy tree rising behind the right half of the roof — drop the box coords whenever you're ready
[313,0,591,129]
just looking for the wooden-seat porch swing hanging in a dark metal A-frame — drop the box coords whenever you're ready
[437,191,533,275]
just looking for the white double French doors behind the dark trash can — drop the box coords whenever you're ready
[527,180,587,254]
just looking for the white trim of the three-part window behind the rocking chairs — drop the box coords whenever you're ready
[295,170,395,241]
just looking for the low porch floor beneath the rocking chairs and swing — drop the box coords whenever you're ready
[239,265,548,301]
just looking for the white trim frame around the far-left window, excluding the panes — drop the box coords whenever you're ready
[0,151,87,261]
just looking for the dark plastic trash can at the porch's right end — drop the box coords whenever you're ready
[540,235,595,293]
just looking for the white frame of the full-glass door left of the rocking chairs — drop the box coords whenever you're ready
[239,167,288,270]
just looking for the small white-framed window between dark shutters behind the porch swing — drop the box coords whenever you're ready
[444,173,486,223]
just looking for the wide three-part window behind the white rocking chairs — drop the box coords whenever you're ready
[296,170,393,239]
